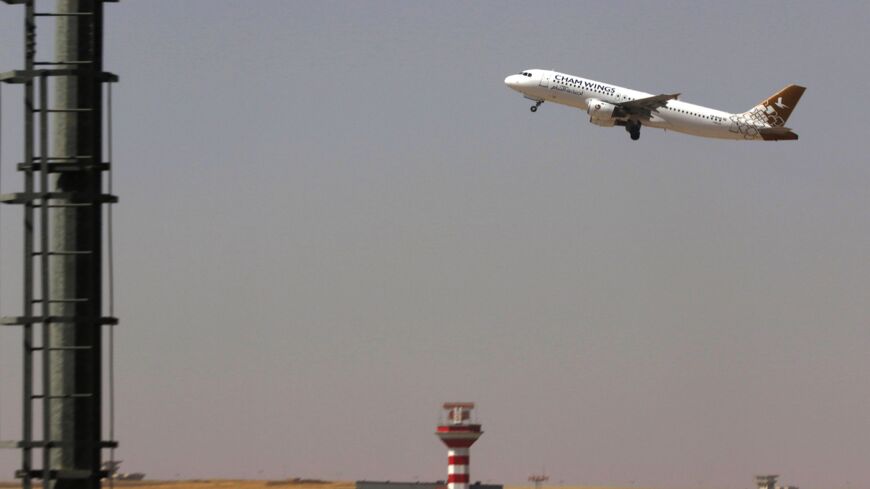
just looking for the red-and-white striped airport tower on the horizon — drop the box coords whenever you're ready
[435,402,483,489]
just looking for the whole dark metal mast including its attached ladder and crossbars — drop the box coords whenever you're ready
[0,0,117,489]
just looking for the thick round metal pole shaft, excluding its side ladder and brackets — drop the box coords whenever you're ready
[49,0,103,489]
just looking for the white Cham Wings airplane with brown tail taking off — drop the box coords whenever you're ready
[504,69,806,141]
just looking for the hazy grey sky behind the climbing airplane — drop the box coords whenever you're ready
[0,0,870,489]
